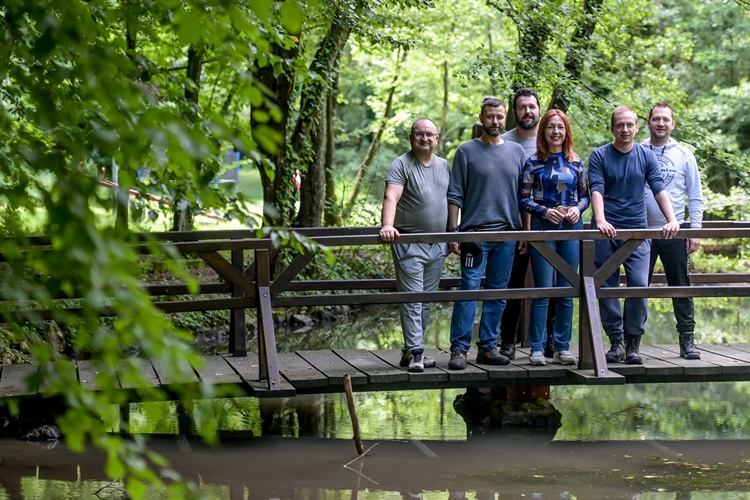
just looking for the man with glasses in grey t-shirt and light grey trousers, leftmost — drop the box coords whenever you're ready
[380,118,450,372]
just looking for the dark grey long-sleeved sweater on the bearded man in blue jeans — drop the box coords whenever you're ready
[448,139,526,231]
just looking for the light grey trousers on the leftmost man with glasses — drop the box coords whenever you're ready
[391,243,448,351]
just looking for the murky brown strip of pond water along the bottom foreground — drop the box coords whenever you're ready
[0,431,750,499]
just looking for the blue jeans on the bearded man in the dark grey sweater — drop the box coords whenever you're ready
[451,241,516,353]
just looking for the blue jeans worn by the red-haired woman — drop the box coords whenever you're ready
[529,217,583,351]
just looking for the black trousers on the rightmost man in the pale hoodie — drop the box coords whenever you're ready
[648,234,695,335]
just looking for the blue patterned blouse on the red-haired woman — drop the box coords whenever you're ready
[518,153,590,217]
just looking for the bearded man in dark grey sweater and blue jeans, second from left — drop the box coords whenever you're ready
[448,97,526,370]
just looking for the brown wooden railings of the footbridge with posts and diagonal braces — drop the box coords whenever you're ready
[1,222,750,390]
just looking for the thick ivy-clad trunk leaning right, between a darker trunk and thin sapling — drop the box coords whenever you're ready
[291,7,351,227]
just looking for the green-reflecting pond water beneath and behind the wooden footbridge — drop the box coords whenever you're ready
[0,299,750,499]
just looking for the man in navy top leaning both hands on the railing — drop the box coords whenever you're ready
[589,106,680,365]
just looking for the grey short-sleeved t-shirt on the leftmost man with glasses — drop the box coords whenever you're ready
[385,152,450,233]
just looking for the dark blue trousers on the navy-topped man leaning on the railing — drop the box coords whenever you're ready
[594,236,651,341]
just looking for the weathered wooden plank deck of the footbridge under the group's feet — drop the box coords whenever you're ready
[5,344,750,398]
